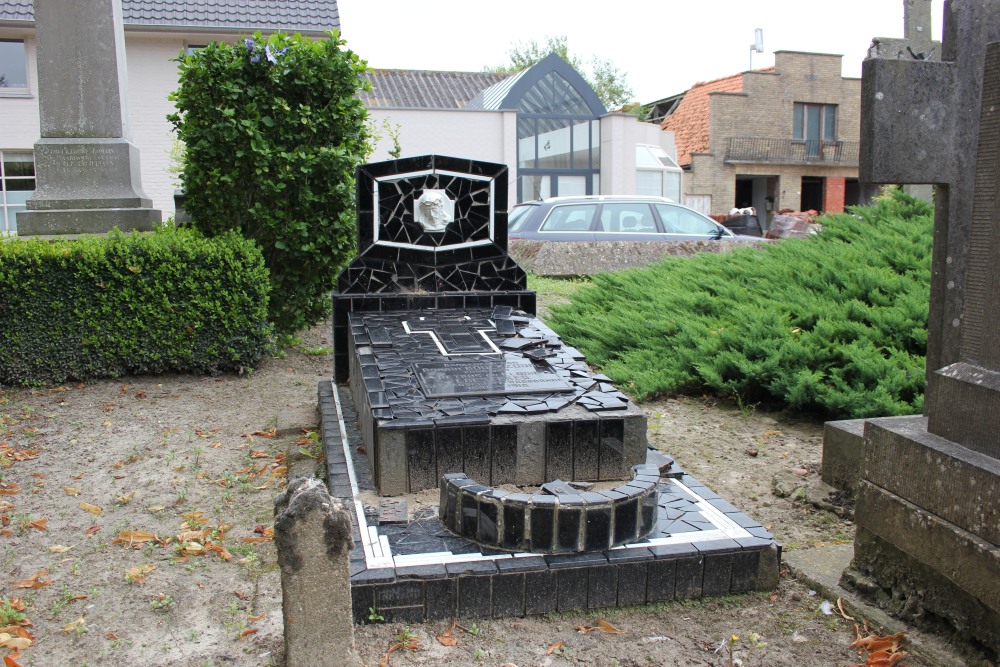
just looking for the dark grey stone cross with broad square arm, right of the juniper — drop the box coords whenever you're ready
[859,0,1000,383]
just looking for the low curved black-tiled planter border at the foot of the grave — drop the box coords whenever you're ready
[438,464,660,554]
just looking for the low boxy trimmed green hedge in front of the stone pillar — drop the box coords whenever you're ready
[0,228,271,384]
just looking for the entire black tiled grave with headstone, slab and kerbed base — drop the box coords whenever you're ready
[320,156,779,622]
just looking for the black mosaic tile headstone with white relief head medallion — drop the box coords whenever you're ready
[333,155,535,382]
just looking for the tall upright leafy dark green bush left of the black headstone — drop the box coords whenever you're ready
[168,32,367,333]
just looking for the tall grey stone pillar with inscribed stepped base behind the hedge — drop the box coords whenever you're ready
[17,0,162,236]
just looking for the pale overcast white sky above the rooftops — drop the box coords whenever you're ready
[337,0,944,103]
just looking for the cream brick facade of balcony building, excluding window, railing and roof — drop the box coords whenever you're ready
[684,51,861,227]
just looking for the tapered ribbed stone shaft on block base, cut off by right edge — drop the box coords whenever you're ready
[927,42,1000,458]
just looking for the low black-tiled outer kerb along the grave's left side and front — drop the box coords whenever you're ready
[318,381,781,624]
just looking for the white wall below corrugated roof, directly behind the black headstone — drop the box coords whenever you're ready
[368,108,517,206]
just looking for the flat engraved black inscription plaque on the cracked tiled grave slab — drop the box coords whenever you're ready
[413,359,573,398]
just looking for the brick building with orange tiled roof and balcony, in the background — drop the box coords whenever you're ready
[654,51,861,230]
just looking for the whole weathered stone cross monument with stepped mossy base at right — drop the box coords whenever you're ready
[824,0,1000,657]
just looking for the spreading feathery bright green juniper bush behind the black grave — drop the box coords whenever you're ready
[550,192,933,418]
